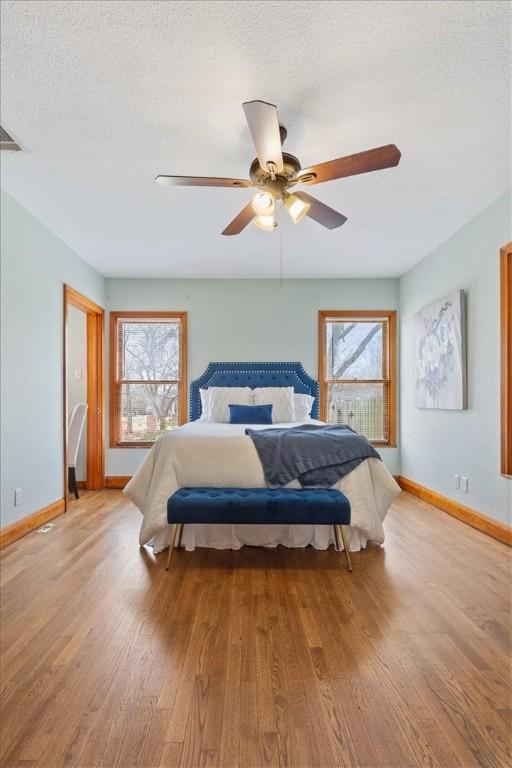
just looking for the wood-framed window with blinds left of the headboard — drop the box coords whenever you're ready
[110,312,187,448]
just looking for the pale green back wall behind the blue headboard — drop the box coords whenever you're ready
[106,280,400,475]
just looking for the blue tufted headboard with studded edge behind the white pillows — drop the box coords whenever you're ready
[190,363,318,421]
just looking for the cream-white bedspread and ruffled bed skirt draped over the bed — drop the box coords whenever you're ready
[125,421,400,552]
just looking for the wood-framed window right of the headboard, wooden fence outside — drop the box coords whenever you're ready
[318,310,396,445]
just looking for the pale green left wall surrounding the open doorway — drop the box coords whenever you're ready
[0,190,105,527]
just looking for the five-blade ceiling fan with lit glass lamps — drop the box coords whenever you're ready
[155,101,400,235]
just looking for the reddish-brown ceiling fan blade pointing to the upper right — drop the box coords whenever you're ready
[298,144,401,184]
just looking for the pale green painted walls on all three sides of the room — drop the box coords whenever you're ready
[1,192,512,526]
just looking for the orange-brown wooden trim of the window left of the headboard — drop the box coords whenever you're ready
[109,312,188,448]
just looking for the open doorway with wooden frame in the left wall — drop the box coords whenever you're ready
[63,285,104,510]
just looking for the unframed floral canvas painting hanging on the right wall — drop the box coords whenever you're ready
[414,290,467,410]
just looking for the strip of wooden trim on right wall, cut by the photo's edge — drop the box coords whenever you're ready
[500,242,512,477]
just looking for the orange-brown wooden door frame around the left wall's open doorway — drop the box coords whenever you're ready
[62,284,105,511]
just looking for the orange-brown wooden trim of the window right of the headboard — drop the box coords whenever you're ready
[318,309,397,448]
